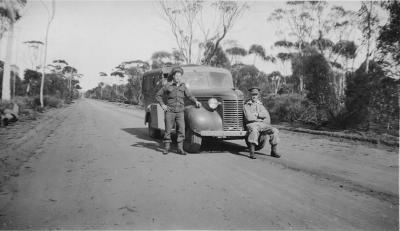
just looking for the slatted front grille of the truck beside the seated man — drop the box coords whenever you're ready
[222,100,243,131]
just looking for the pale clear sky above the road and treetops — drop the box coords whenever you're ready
[0,0,359,89]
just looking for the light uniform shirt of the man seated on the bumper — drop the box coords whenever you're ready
[243,99,271,124]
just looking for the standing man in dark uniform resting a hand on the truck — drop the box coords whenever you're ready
[156,67,201,155]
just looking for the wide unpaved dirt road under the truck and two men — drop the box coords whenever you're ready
[0,99,399,230]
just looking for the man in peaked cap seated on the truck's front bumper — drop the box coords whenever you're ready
[244,87,280,159]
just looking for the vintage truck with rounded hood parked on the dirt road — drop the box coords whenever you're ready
[142,65,266,153]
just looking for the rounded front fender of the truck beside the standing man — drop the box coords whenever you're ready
[185,106,223,133]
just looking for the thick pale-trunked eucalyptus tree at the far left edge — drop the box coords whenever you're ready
[0,0,26,100]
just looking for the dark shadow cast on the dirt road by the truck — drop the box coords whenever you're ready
[121,127,265,158]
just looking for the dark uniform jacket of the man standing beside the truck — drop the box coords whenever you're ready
[156,83,197,112]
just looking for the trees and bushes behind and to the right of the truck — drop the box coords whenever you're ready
[86,1,400,139]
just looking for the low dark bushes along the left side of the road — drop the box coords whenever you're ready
[0,58,80,125]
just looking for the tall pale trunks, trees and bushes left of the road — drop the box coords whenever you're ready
[0,0,81,125]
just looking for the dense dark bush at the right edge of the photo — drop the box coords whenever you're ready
[346,62,400,133]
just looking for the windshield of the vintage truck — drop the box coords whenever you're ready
[182,72,233,89]
